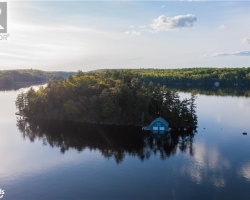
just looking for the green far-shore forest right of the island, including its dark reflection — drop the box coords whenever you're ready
[89,68,250,96]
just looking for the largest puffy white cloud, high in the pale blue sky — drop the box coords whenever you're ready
[150,14,197,31]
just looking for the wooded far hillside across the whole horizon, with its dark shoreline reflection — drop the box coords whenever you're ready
[0,67,250,93]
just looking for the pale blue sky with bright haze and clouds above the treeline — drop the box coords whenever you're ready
[0,0,250,71]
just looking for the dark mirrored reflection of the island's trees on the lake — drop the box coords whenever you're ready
[17,119,195,163]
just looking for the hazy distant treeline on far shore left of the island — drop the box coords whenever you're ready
[0,69,74,88]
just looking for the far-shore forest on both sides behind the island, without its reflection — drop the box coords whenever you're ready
[3,68,250,89]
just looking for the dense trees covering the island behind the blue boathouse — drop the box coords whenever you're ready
[16,70,197,127]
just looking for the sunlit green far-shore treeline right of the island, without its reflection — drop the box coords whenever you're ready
[90,67,250,88]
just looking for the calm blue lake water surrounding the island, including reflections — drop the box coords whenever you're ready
[0,86,250,200]
